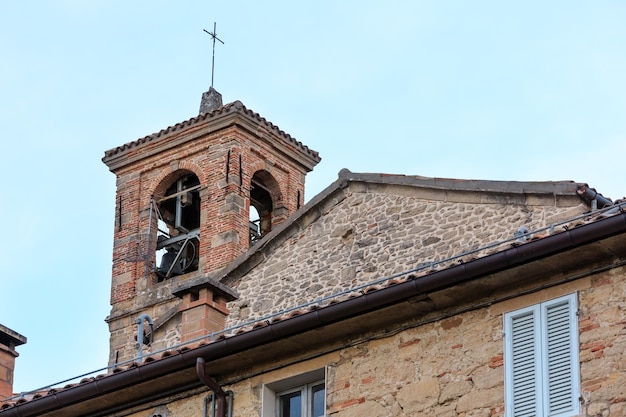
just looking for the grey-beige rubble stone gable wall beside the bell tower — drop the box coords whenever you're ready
[227,183,587,325]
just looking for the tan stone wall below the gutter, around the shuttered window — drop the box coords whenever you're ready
[119,267,626,417]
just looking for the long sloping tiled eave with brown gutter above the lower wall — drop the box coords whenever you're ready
[0,201,626,417]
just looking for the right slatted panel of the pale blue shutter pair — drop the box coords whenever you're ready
[542,296,578,417]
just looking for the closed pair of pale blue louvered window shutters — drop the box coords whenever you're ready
[504,294,580,417]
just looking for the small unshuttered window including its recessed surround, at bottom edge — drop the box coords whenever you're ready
[263,369,326,417]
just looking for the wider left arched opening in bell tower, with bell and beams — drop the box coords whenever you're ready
[155,173,200,282]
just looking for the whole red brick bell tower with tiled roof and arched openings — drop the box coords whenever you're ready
[102,87,320,365]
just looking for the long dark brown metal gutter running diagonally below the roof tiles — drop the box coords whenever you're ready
[0,212,626,417]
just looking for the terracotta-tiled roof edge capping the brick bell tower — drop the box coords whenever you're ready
[103,100,321,162]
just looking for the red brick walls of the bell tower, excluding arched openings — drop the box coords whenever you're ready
[107,114,314,363]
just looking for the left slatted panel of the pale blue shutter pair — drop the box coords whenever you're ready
[507,307,541,417]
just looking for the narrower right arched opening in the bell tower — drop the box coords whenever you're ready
[250,171,280,246]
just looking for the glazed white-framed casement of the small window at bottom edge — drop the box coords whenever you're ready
[277,381,326,417]
